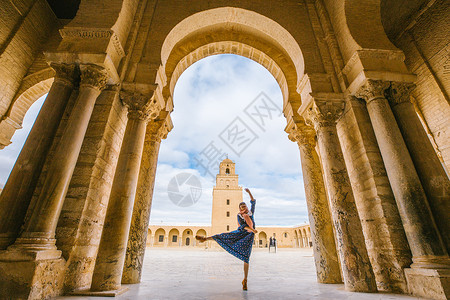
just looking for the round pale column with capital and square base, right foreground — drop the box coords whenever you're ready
[356,80,450,299]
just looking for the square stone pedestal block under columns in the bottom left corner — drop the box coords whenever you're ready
[0,250,65,300]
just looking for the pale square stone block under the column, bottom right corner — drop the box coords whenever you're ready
[405,268,450,300]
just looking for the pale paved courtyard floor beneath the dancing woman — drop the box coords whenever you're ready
[58,248,419,300]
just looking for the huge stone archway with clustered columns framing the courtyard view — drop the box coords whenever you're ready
[0,0,450,298]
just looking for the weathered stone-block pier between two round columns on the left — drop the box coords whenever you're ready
[56,90,126,291]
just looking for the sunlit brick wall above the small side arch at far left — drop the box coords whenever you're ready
[0,0,58,149]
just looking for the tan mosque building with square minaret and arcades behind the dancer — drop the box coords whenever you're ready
[147,158,312,248]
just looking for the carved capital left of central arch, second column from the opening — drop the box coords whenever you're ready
[120,89,161,121]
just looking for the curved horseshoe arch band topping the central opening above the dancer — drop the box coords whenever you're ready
[156,7,312,116]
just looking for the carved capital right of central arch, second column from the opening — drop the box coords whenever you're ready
[306,99,345,130]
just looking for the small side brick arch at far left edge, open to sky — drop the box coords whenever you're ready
[0,68,55,149]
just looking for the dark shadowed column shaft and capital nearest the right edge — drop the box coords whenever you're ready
[387,82,450,253]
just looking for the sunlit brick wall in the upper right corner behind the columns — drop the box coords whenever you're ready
[390,0,450,172]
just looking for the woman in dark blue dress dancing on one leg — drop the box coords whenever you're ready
[195,189,258,290]
